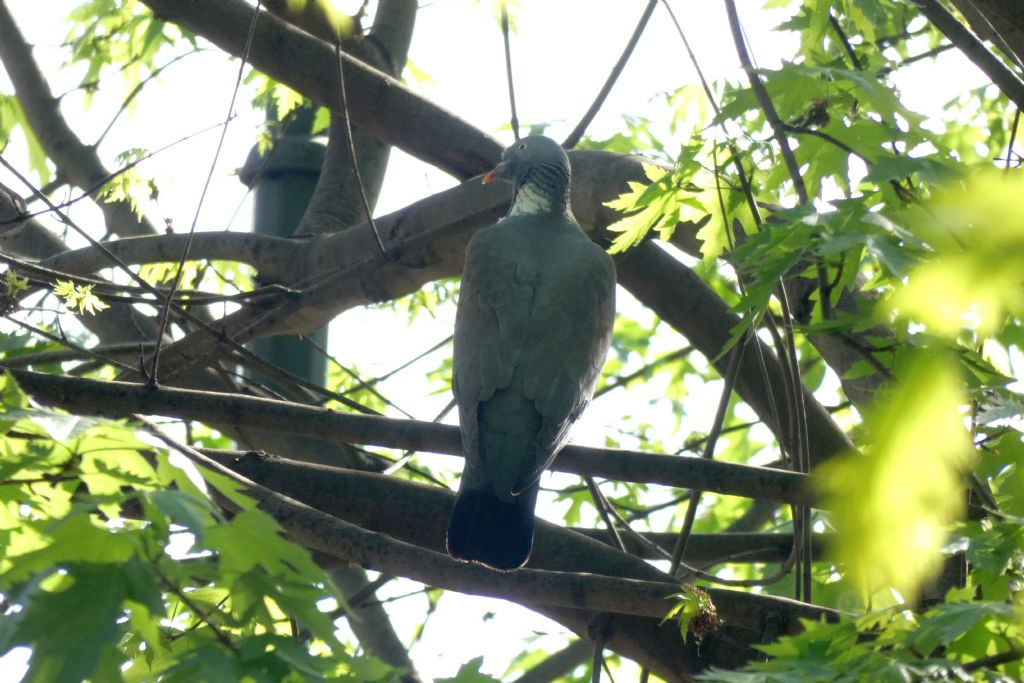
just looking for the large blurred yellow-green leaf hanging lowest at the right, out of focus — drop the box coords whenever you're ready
[818,351,972,601]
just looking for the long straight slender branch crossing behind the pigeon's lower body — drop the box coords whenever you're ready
[10,369,816,505]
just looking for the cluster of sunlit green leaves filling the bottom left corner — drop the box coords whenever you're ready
[0,376,391,681]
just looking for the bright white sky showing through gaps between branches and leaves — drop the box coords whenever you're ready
[0,0,983,681]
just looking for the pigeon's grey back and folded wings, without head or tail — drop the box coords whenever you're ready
[453,221,614,488]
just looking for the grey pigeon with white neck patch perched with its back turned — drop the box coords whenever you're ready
[446,135,615,571]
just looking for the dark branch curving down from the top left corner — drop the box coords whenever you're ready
[0,0,156,236]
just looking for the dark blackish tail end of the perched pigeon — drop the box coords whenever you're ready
[447,485,539,571]
